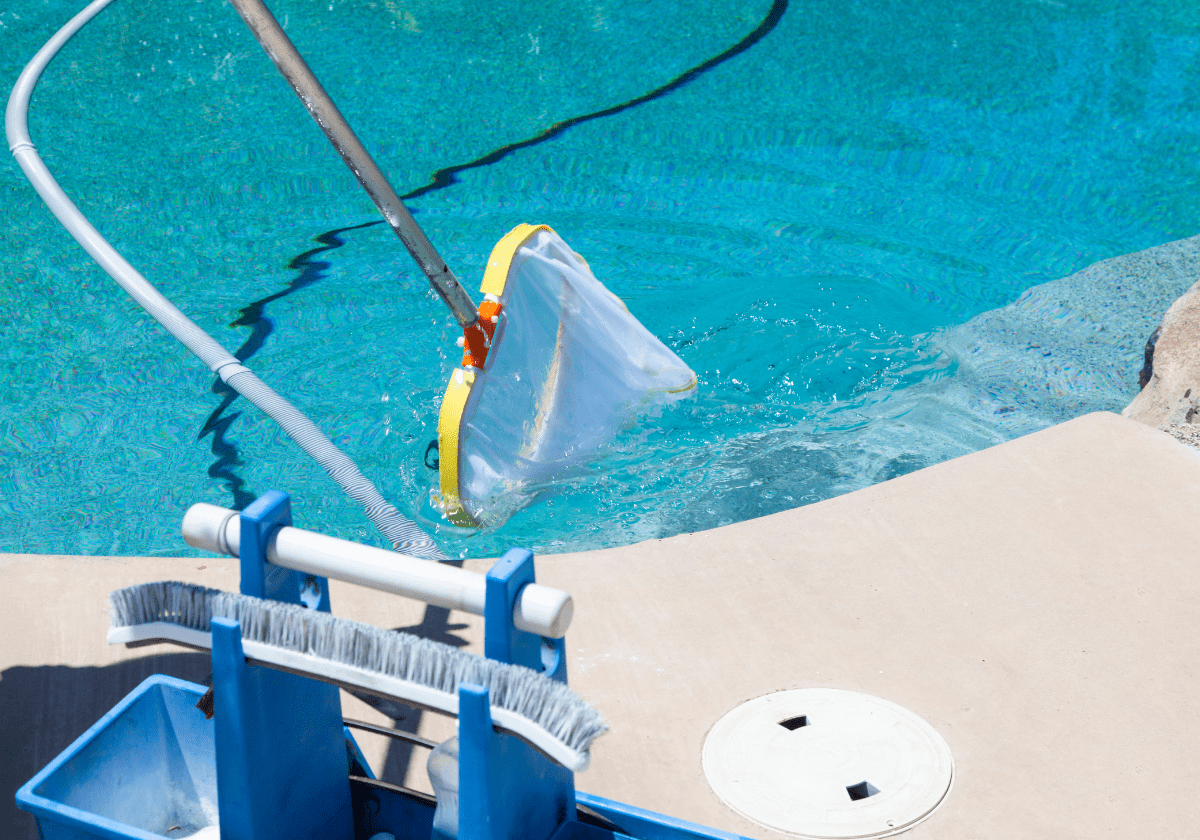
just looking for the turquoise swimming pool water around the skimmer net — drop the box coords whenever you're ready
[0,0,1200,554]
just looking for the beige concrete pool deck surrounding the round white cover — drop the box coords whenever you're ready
[0,413,1200,840]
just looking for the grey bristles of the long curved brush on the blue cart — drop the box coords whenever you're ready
[109,581,608,751]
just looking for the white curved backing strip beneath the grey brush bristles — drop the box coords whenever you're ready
[108,622,592,773]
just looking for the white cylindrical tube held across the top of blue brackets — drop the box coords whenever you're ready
[184,503,575,638]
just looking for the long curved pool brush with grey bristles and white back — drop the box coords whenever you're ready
[108,581,608,772]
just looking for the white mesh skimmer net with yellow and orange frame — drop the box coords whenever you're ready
[434,224,696,527]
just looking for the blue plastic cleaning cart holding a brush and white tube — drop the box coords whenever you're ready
[17,492,739,840]
